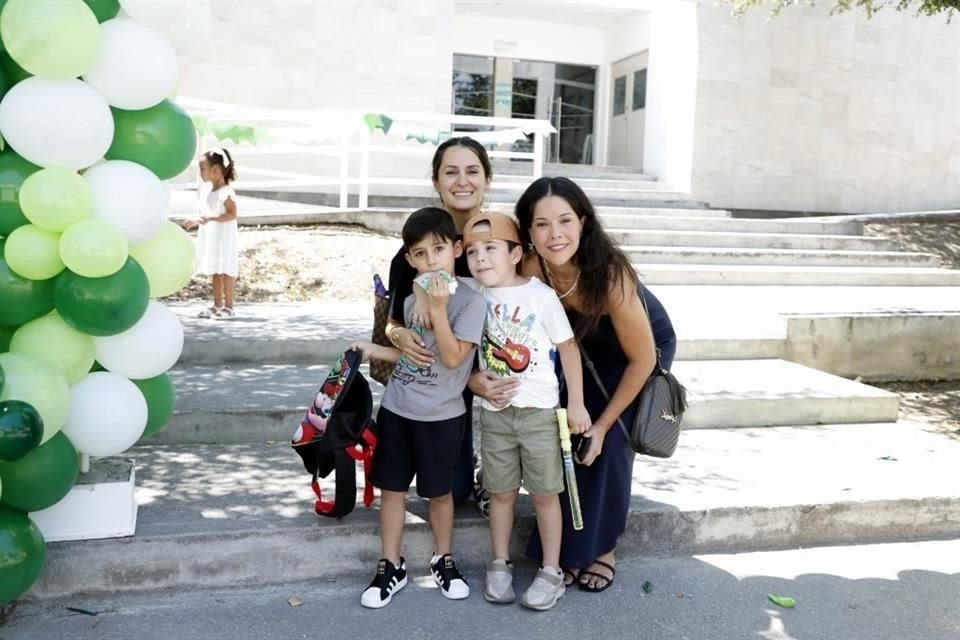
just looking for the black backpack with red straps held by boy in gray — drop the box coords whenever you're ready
[290,351,377,518]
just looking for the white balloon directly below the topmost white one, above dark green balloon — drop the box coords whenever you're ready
[83,18,177,110]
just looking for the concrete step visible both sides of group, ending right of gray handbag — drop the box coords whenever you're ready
[148,360,899,444]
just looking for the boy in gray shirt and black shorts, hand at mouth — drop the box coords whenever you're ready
[352,207,486,609]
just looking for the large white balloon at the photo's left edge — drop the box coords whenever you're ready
[0,78,113,169]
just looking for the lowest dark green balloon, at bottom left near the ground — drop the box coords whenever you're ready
[0,507,47,607]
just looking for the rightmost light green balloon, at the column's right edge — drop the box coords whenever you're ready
[130,220,195,298]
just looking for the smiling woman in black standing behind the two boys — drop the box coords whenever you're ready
[386,136,493,504]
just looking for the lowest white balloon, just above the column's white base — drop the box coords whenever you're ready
[63,371,147,456]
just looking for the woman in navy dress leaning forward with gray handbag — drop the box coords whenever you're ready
[472,178,676,592]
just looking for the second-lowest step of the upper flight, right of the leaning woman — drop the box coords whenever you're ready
[621,245,940,268]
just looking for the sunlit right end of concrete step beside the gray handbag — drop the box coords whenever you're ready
[673,360,900,429]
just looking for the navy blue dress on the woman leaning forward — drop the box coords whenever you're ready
[527,289,677,569]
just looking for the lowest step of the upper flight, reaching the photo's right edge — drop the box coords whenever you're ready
[633,264,960,287]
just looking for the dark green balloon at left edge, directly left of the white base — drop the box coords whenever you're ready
[0,428,78,512]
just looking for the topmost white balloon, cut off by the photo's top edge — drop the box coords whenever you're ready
[120,0,210,55]
